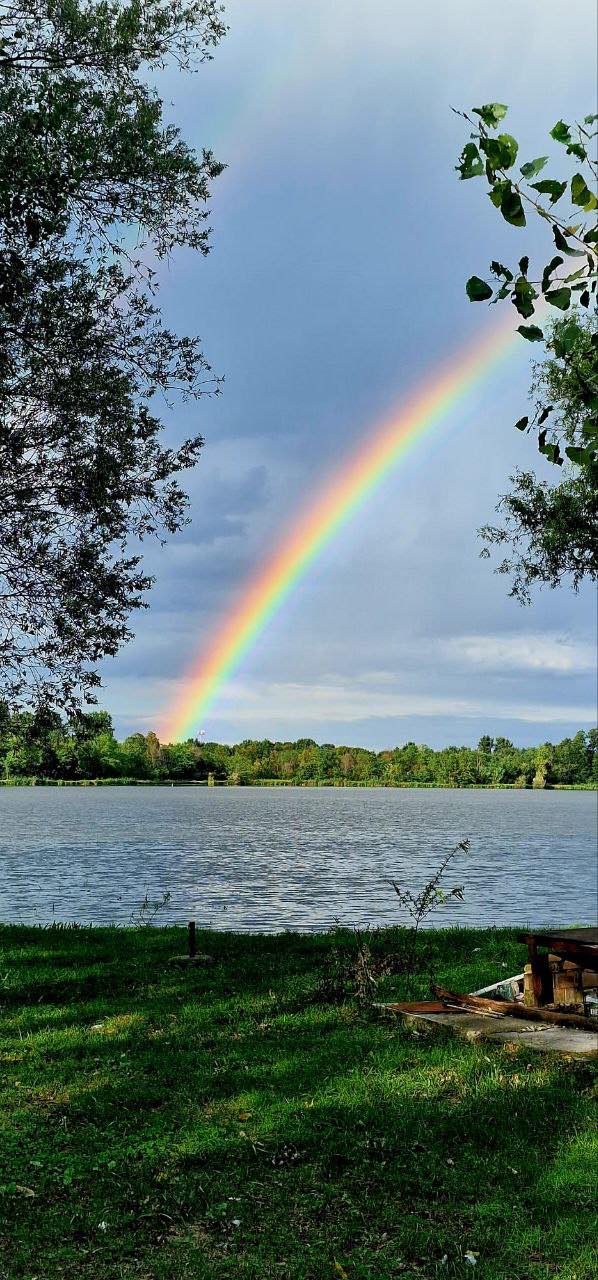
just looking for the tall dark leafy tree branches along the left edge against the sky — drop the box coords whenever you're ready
[0,0,224,709]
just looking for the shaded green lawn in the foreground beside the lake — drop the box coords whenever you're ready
[0,927,597,1280]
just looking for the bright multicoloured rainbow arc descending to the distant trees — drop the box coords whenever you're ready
[163,321,520,741]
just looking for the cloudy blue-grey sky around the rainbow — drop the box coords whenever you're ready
[100,0,595,750]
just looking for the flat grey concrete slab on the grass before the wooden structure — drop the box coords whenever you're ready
[383,1005,598,1057]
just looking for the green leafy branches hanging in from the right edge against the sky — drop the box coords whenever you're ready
[457,102,598,603]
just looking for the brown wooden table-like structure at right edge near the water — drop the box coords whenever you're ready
[519,928,598,1011]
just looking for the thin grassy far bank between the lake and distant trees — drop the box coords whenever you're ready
[0,777,598,791]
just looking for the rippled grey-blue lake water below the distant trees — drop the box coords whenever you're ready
[0,787,597,931]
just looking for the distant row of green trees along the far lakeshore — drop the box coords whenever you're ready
[0,705,598,787]
